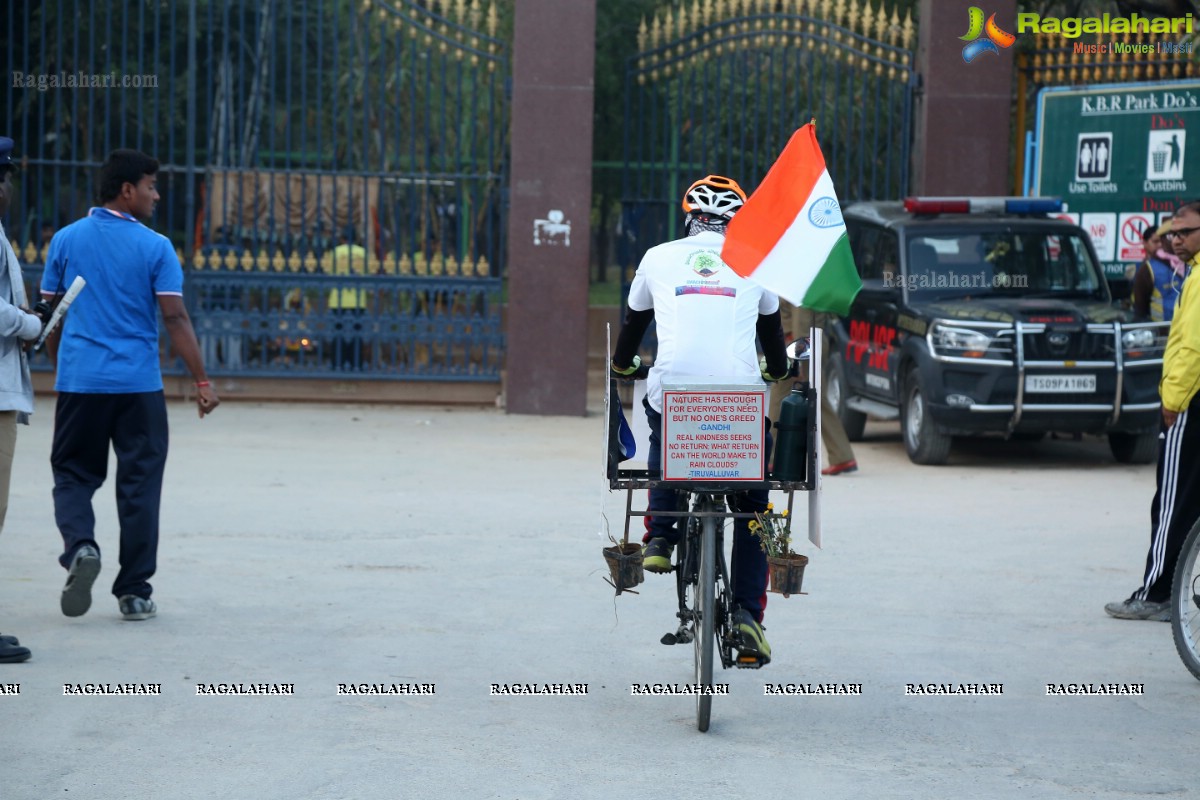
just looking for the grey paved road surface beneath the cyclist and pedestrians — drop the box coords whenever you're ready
[0,401,1200,800]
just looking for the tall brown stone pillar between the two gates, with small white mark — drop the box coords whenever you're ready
[505,0,595,416]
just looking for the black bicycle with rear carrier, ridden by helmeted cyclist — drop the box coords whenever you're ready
[610,331,821,733]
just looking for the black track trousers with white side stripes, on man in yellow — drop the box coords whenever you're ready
[1133,397,1200,603]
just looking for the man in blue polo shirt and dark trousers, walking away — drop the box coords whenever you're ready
[42,150,220,620]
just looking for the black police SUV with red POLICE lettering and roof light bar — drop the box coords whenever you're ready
[827,198,1168,464]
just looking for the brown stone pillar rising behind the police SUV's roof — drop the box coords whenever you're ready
[912,0,1024,196]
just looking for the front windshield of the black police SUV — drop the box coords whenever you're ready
[904,228,1106,300]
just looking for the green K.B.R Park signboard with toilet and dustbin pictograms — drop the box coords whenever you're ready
[1032,80,1200,278]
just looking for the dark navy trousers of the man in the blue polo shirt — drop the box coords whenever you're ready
[50,391,167,597]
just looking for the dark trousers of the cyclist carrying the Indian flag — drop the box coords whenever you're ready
[642,401,772,622]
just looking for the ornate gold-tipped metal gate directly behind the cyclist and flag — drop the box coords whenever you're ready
[619,0,914,275]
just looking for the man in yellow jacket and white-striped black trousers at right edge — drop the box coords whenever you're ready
[1104,201,1200,622]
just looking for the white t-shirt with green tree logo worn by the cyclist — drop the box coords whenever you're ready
[629,231,779,413]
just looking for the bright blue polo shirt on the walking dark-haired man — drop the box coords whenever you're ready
[42,209,184,395]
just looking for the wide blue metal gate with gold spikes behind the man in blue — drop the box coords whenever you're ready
[2,0,509,381]
